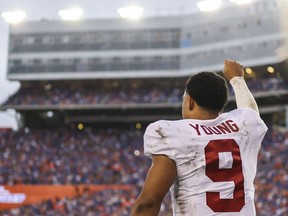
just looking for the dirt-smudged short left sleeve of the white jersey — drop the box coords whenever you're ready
[144,121,176,161]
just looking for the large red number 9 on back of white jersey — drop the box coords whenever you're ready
[205,139,245,212]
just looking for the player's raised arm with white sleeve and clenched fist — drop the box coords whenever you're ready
[223,59,259,113]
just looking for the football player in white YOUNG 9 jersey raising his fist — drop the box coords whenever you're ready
[132,60,267,216]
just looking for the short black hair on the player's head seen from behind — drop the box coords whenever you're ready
[186,71,228,111]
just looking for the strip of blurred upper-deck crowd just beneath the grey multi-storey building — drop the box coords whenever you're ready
[5,77,287,106]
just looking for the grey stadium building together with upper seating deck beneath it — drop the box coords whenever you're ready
[0,0,288,127]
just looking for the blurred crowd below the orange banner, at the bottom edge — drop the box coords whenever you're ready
[0,187,172,216]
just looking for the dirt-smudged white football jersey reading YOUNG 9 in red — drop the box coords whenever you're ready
[144,108,267,216]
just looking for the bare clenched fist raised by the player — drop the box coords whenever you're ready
[223,59,244,81]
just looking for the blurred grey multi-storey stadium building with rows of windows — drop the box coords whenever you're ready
[7,0,287,80]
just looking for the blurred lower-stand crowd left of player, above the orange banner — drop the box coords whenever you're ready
[0,128,149,185]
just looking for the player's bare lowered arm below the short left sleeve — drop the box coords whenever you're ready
[131,155,177,216]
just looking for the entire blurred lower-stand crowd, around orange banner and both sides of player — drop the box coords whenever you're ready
[0,125,288,216]
